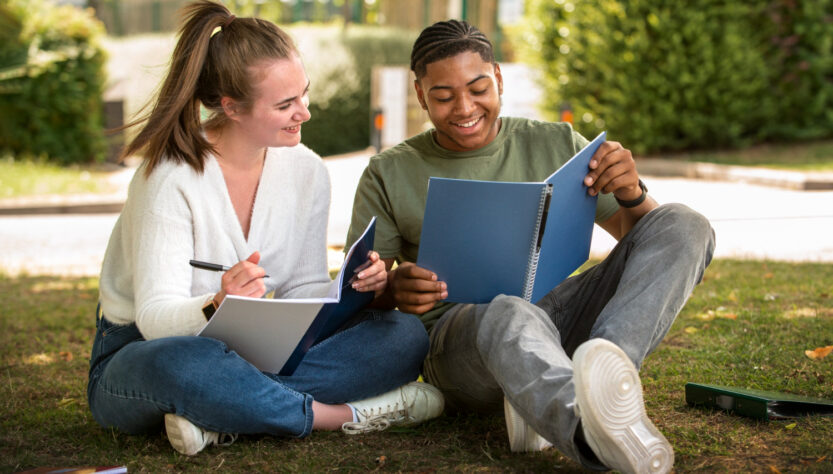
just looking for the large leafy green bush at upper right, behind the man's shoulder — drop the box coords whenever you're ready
[524,0,833,152]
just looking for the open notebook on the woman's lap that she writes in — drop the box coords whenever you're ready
[199,217,376,375]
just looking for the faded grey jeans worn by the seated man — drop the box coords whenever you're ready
[423,204,714,467]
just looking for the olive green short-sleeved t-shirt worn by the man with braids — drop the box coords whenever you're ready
[347,117,619,330]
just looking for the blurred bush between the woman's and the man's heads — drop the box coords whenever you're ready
[288,25,416,156]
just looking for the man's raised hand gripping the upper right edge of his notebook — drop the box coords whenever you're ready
[584,142,642,201]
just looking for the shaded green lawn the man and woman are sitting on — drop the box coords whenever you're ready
[0,260,833,472]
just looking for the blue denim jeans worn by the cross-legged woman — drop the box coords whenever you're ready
[87,310,428,437]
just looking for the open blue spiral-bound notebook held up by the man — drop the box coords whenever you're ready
[417,132,605,303]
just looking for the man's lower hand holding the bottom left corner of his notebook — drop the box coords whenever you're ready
[388,262,448,314]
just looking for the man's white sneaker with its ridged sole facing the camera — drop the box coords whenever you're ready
[573,339,674,474]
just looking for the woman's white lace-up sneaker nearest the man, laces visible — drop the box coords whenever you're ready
[341,382,445,434]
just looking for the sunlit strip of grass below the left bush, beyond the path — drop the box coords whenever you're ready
[0,157,113,199]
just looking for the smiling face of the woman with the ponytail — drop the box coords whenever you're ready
[237,54,310,147]
